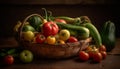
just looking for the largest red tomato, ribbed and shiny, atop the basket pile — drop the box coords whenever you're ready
[42,21,59,37]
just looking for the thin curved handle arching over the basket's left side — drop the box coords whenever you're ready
[18,14,44,41]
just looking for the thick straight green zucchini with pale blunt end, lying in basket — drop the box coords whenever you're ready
[56,22,90,39]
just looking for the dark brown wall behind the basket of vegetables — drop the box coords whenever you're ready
[0,0,120,38]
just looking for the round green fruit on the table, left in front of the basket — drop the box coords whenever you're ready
[20,50,33,63]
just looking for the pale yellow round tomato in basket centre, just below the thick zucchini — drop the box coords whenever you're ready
[59,29,70,41]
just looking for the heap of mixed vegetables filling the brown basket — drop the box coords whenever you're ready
[14,8,102,47]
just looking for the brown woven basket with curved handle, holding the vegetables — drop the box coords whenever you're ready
[19,14,91,58]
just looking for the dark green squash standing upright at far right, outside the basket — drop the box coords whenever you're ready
[101,21,116,52]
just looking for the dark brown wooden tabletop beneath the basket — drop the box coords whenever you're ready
[0,38,120,69]
